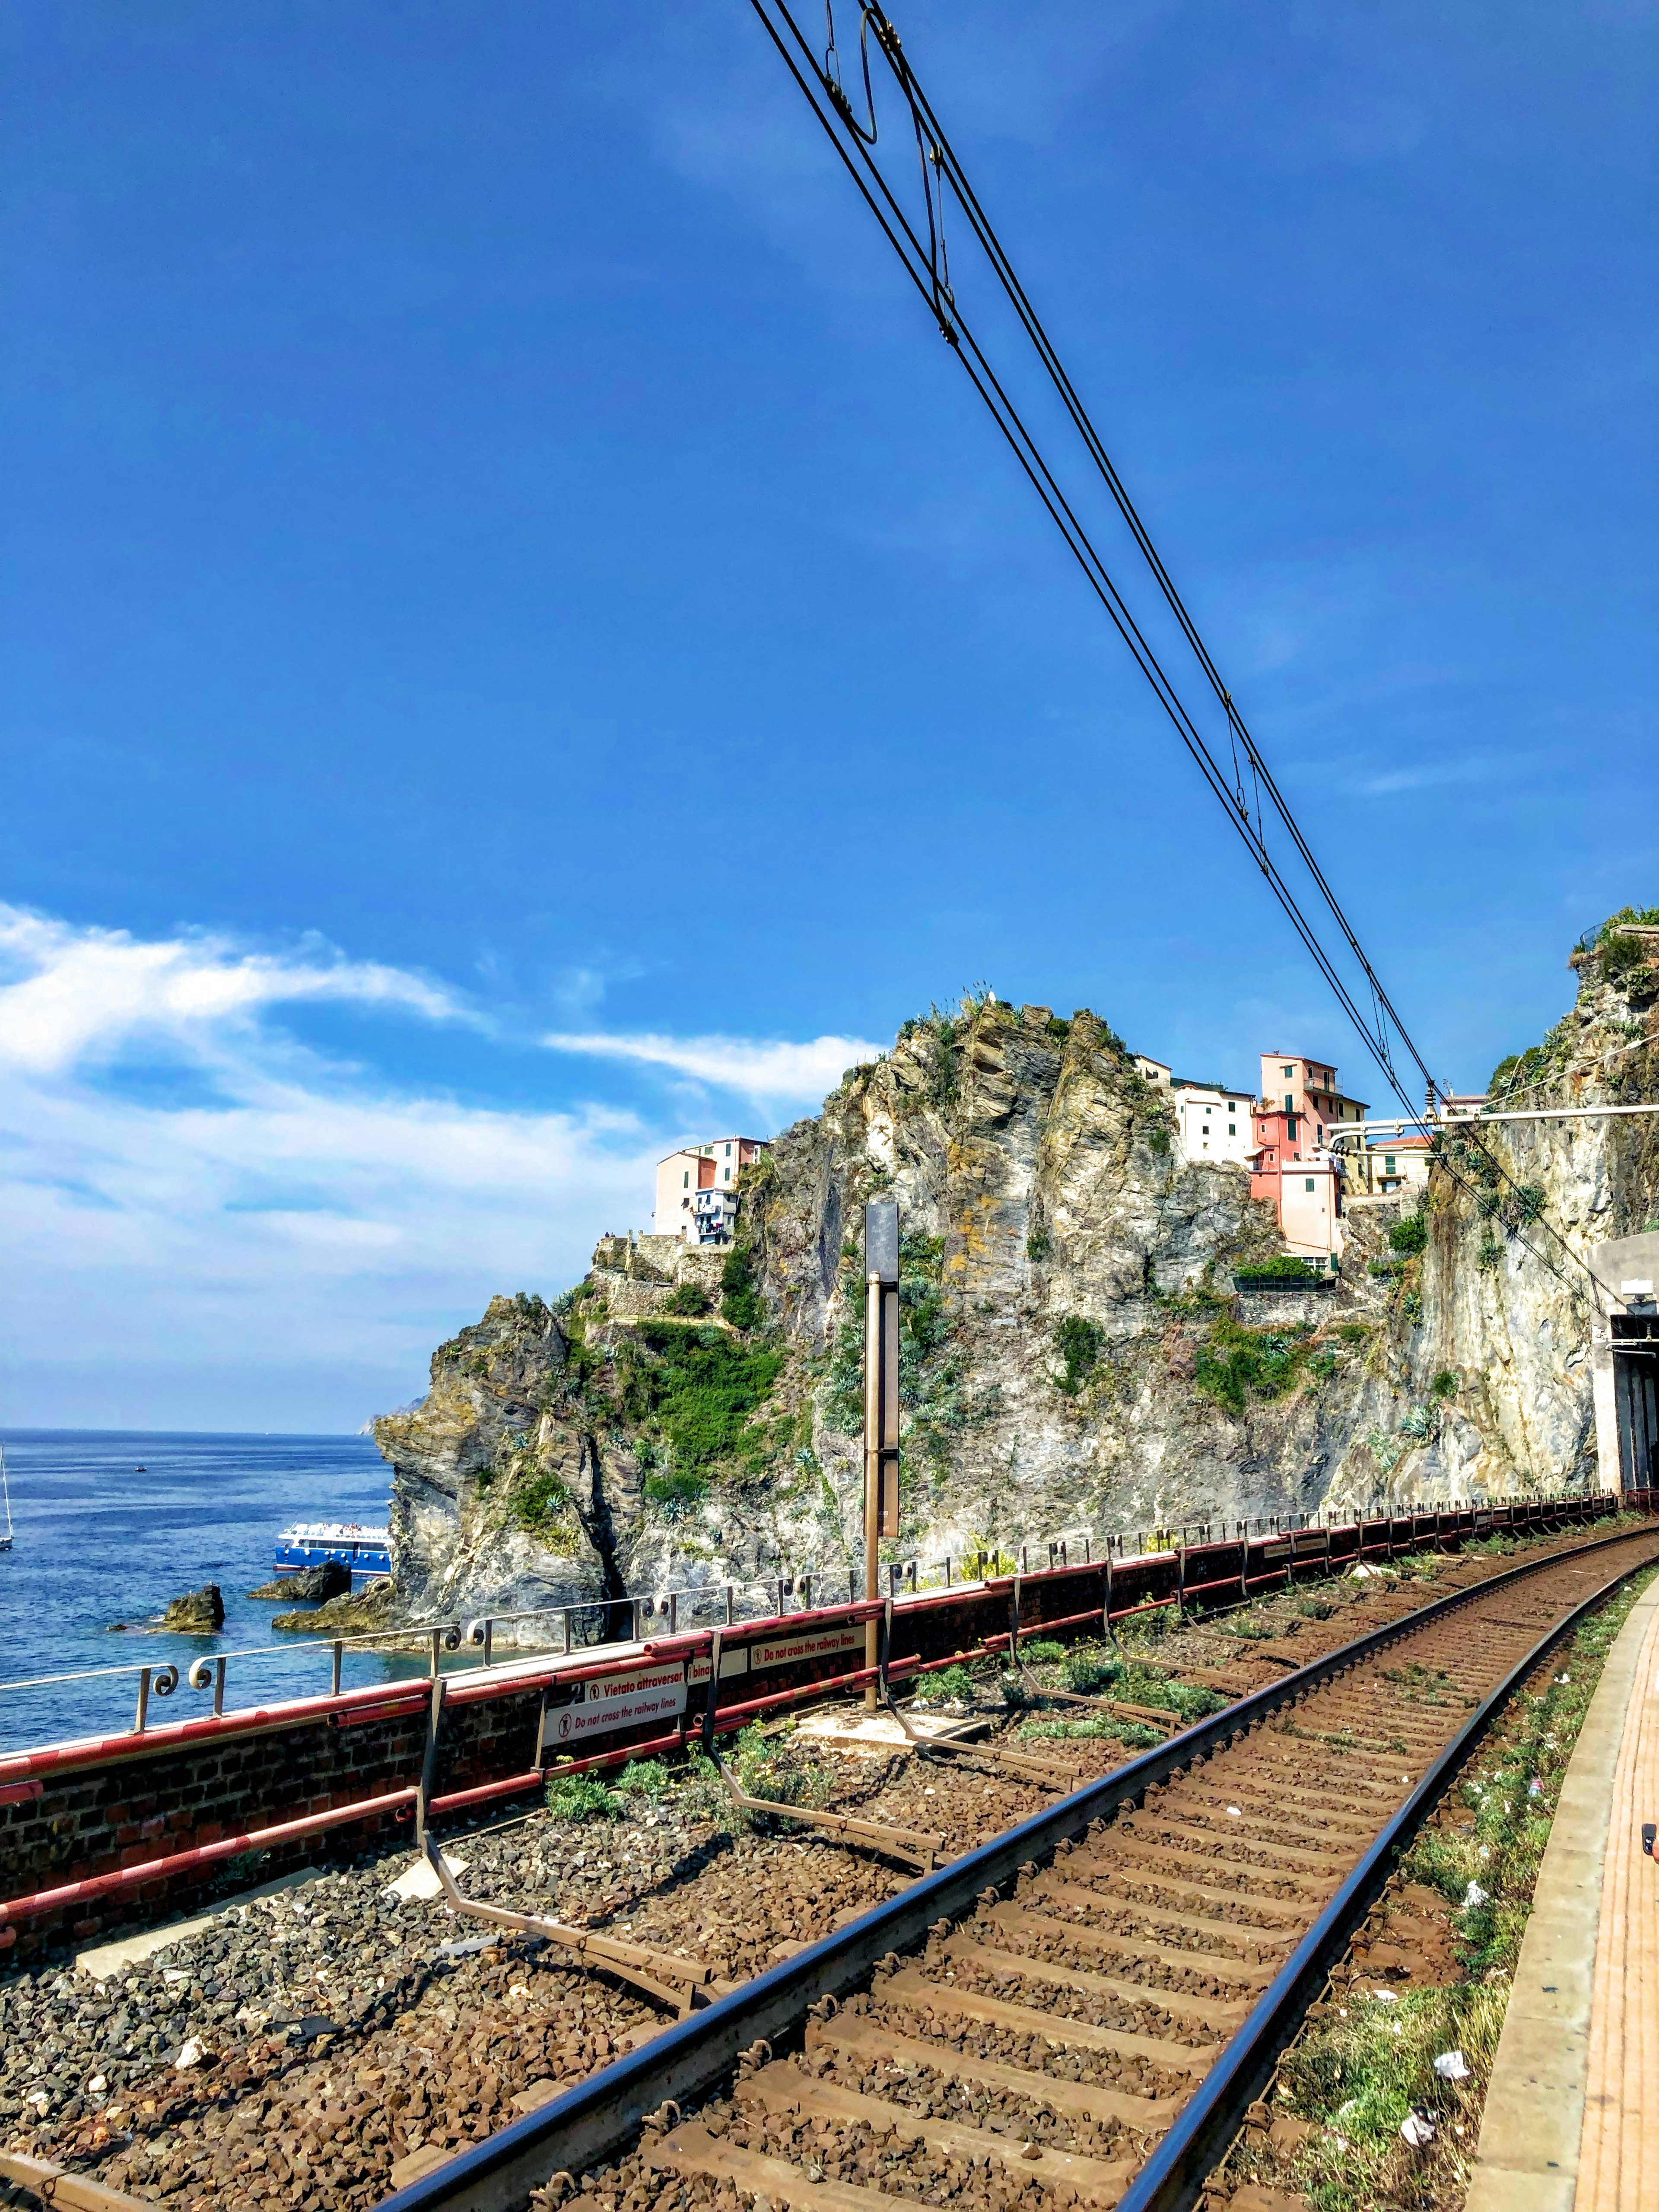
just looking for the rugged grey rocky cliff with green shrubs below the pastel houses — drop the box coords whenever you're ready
[376,925,1659,1612]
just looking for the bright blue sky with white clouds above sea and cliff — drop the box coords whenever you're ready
[0,0,1659,1429]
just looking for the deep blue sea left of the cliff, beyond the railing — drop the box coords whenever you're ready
[0,1429,473,1754]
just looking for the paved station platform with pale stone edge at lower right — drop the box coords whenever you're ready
[1467,1584,1659,2212]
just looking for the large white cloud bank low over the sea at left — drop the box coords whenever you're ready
[0,909,666,1429]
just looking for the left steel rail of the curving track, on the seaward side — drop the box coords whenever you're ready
[376,1526,1655,2212]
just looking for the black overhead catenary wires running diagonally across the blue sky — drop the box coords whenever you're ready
[750,0,1595,1283]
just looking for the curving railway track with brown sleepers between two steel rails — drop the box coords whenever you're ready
[374,1529,1659,2212]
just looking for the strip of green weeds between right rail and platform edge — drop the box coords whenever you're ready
[1225,1568,1659,2212]
